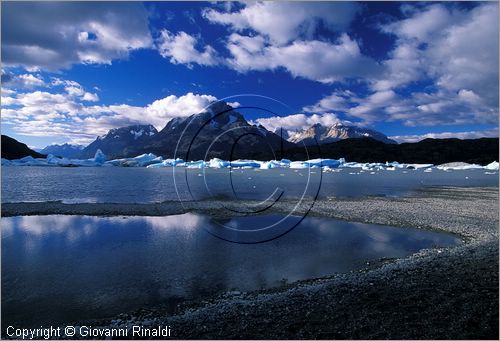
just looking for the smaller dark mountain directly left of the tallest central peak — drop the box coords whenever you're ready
[78,124,158,159]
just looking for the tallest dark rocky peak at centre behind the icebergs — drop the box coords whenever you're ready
[127,102,294,160]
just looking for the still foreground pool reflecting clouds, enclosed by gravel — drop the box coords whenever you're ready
[1,213,462,327]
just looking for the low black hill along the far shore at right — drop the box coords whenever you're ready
[285,138,499,165]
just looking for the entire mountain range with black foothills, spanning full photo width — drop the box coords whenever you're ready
[2,102,498,164]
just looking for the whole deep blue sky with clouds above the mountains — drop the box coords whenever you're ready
[1,1,499,148]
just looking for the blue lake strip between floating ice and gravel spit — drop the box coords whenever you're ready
[2,167,498,203]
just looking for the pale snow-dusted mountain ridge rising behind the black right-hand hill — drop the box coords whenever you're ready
[283,122,396,145]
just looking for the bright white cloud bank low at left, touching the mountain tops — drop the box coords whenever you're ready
[1,85,221,144]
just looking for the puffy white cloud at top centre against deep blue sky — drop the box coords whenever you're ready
[202,1,379,83]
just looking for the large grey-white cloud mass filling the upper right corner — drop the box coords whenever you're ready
[305,3,499,126]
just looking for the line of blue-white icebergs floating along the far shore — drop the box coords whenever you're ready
[2,150,499,172]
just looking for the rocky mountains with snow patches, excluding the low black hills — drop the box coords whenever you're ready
[61,102,396,160]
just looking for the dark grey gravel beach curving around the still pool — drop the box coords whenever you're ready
[2,188,499,339]
